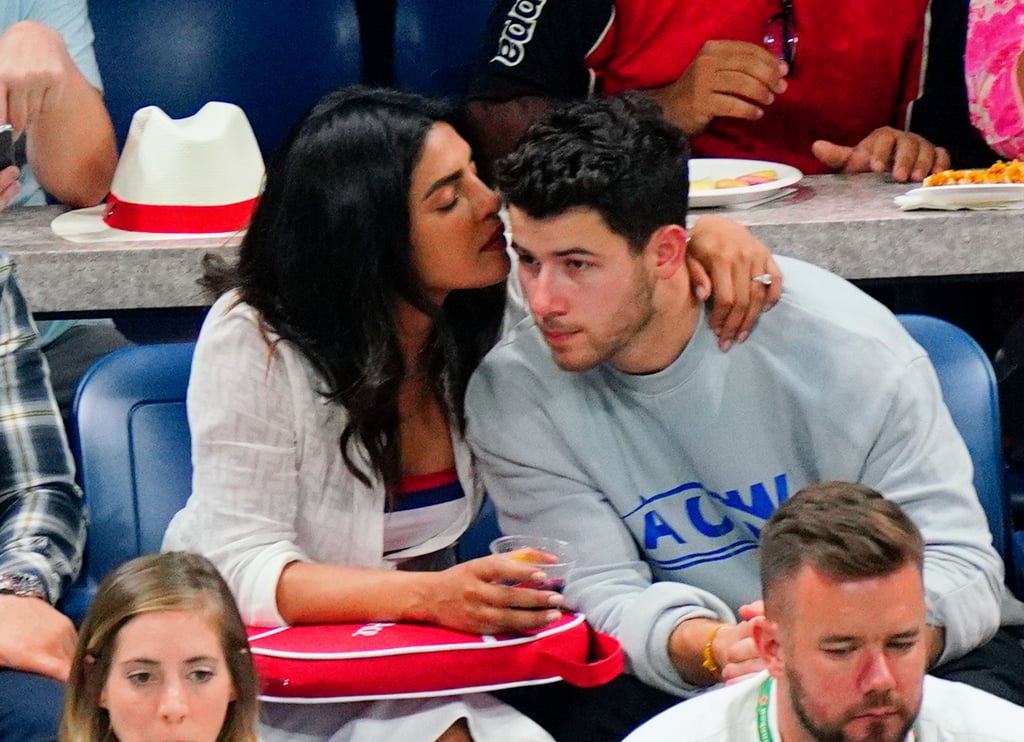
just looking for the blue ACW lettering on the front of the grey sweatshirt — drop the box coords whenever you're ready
[623,474,790,570]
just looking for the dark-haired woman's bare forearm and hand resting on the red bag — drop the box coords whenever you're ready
[276,556,562,634]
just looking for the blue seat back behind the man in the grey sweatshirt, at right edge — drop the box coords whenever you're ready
[898,314,1024,595]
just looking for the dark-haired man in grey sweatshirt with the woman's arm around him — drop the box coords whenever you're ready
[467,96,1024,740]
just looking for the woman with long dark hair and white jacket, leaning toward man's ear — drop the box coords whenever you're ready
[164,87,770,740]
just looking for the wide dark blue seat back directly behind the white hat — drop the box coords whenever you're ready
[89,0,362,158]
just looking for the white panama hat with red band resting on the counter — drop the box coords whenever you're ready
[50,101,264,243]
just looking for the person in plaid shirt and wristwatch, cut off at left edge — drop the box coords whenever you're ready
[0,251,85,740]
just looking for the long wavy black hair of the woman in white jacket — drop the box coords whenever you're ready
[205,86,505,501]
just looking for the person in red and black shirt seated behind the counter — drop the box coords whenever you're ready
[469,0,949,181]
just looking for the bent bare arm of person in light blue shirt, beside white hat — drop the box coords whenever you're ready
[0,20,117,206]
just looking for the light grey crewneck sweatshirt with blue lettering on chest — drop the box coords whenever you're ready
[467,258,1004,696]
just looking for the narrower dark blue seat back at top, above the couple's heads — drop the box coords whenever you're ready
[394,0,494,97]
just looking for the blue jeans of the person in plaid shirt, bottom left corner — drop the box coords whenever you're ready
[0,669,63,742]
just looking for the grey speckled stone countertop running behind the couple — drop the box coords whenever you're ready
[0,174,1024,313]
